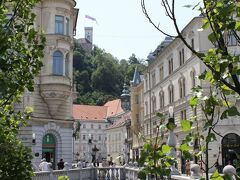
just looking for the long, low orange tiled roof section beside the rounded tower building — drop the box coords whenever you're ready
[73,104,107,121]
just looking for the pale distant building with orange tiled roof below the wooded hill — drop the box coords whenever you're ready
[73,99,123,161]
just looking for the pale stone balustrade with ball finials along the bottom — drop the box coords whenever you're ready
[32,165,237,180]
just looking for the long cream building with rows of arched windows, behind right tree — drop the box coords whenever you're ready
[138,17,240,172]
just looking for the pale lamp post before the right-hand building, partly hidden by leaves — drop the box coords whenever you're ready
[167,106,180,175]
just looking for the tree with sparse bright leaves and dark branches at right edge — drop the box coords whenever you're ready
[141,0,240,179]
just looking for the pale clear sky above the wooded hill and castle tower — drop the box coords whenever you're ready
[76,0,199,60]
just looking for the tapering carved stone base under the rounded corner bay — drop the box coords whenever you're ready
[39,75,72,117]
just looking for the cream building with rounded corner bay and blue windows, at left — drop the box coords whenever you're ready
[16,0,78,168]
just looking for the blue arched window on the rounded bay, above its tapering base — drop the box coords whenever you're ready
[53,51,63,75]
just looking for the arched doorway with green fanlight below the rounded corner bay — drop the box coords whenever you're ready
[42,134,56,169]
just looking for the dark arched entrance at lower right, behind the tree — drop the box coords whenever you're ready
[222,133,240,167]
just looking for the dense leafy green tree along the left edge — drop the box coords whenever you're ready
[0,0,45,180]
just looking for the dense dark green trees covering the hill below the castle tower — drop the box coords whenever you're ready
[73,44,145,105]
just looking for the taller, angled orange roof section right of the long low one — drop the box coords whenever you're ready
[104,99,123,117]
